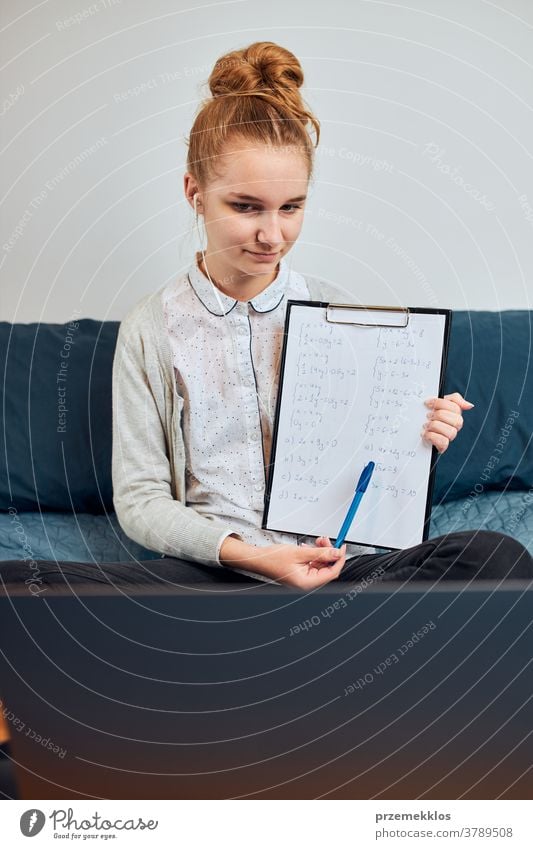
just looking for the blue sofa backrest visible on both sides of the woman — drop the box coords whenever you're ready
[0,310,533,513]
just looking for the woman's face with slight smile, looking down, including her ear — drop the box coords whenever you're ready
[185,140,309,297]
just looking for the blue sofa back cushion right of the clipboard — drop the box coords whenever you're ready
[433,310,533,503]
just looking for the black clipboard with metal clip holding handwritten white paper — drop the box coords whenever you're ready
[262,300,452,550]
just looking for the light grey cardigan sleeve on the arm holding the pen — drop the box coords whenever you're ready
[112,308,241,566]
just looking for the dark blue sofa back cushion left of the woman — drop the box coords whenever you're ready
[0,319,119,513]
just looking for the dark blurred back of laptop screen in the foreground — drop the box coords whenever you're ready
[0,581,533,799]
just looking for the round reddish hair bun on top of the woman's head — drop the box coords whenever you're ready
[209,41,304,97]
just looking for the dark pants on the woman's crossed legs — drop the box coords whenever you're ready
[0,531,533,595]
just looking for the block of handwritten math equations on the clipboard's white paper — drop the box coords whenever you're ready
[276,317,433,503]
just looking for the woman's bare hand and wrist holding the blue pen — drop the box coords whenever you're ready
[219,536,346,590]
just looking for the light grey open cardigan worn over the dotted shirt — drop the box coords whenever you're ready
[112,276,364,566]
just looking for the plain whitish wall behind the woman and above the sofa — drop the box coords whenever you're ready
[0,0,533,322]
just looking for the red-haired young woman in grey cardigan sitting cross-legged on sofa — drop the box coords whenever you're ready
[113,42,533,589]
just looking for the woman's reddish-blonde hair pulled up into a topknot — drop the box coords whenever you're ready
[187,41,320,188]
